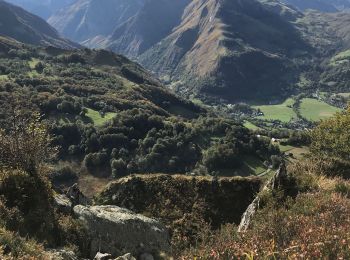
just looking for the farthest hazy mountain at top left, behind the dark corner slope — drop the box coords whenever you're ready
[7,0,76,20]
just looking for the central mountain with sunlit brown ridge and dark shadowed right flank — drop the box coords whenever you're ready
[102,0,311,100]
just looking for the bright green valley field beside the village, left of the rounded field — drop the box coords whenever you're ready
[253,98,297,122]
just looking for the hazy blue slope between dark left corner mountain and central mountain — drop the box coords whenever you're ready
[48,0,145,45]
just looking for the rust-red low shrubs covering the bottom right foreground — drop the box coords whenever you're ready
[178,192,350,259]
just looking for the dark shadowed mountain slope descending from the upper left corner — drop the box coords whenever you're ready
[0,0,78,48]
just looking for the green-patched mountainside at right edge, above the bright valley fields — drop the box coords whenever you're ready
[299,12,350,93]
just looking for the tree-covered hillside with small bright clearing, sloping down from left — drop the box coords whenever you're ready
[0,38,279,191]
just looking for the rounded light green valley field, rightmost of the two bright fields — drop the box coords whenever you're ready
[300,98,341,122]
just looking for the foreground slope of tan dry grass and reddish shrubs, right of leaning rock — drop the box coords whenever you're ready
[178,157,350,259]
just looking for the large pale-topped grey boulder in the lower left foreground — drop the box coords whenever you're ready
[73,205,170,257]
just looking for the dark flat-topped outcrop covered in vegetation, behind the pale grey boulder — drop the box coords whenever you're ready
[96,174,262,228]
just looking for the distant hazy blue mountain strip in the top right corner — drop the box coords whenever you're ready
[282,0,350,13]
